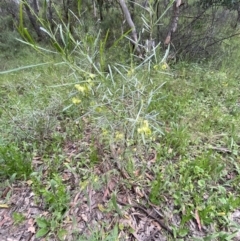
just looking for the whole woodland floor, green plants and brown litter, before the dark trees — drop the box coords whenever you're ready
[0,0,240,240]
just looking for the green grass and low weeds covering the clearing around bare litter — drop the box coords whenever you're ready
[0,38,240,240]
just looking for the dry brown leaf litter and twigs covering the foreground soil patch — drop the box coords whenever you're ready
[0,129,240,241]
